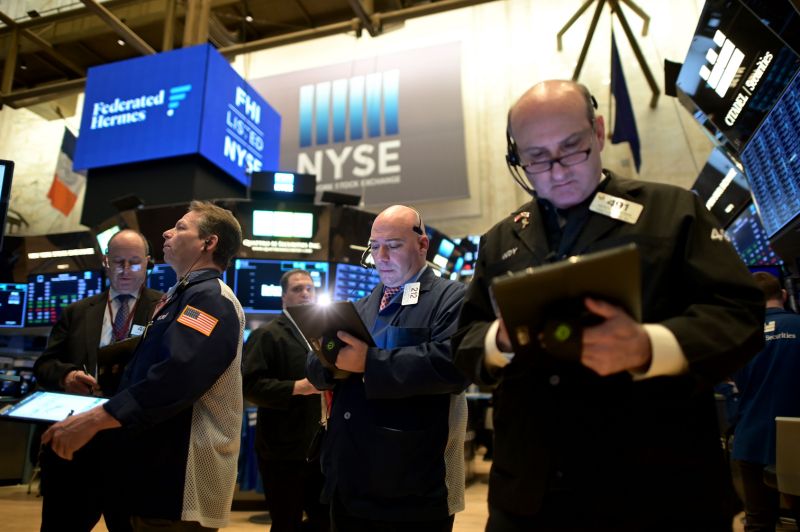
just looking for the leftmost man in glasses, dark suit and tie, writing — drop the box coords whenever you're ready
[34,229,161,532]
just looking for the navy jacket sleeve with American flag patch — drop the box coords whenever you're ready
[104,283,242,428]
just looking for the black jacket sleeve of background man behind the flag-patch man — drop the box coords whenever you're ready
[242,327,294,410]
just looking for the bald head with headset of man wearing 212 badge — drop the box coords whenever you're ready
[369,205,429,287]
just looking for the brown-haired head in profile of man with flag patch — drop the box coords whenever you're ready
[163,201,242,276]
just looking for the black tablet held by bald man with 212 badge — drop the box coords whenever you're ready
[283,301,375,369]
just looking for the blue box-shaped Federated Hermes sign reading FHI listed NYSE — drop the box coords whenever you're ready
[74,45,280,184]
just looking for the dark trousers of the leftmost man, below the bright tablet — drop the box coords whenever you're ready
[39,438,132,532]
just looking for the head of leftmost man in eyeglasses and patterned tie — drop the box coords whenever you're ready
[103,229,150,294]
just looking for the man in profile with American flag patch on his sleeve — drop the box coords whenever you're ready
[42,201,244,530]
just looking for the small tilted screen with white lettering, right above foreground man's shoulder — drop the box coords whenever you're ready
[692,148,750,227]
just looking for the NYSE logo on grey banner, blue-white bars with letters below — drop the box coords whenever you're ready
[297,69,401,183]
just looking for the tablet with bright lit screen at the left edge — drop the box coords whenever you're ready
[0,391,108,423]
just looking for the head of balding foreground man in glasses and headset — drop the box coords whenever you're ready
[507,80,605,209]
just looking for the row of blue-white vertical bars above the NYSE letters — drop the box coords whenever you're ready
[299,69,400,148]
